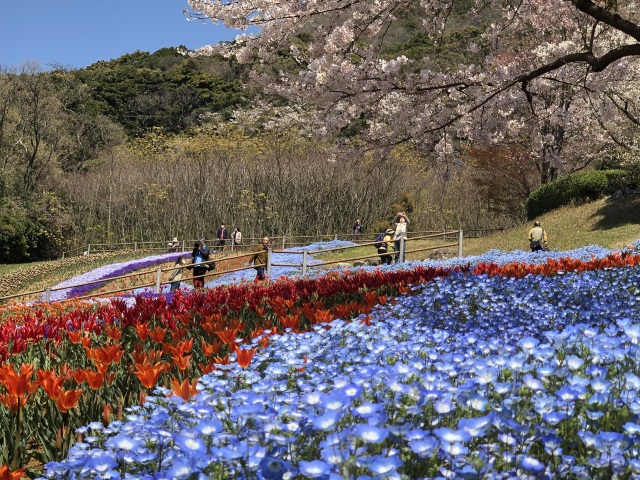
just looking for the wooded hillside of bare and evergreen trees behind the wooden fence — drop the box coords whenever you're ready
[0,2,628,262]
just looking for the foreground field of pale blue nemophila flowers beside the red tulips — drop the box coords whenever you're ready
[44,244,640,480]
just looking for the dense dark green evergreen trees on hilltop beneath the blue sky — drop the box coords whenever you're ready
[75,48,246,137]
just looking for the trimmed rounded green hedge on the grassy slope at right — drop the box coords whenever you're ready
[526,170,628,219]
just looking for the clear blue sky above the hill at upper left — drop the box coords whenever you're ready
[0,0,239,69]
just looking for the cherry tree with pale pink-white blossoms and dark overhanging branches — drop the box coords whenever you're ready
[188,0,640,182]
